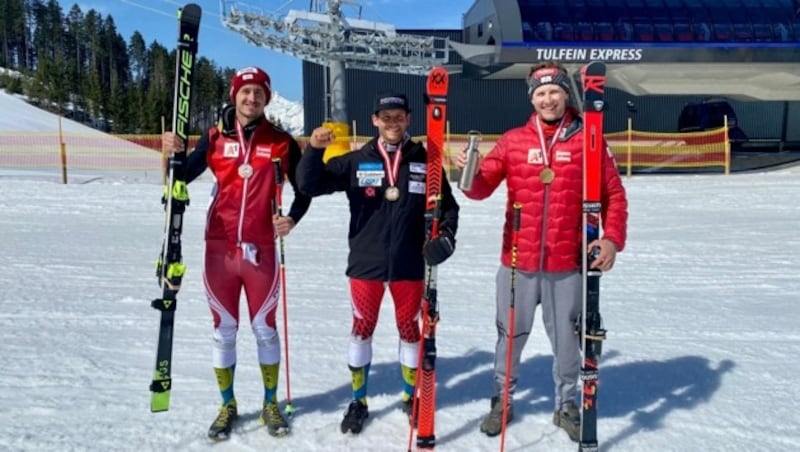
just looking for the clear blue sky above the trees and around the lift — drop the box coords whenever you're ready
[86,0,474,101]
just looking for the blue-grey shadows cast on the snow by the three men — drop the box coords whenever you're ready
[286,350,735,450]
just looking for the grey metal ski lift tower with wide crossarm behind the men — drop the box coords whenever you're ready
[220,0,450,150]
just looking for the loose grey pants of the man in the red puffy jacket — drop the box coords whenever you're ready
[494,265,581,409]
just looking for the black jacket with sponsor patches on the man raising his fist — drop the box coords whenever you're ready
[297,138,458,281]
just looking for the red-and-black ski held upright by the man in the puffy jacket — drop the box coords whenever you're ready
[577,62,606,452]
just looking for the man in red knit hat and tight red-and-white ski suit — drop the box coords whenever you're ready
[162,67,311,440]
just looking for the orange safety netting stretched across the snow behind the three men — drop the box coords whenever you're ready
[0,128,730,172]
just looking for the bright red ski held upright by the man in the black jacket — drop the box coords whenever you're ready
[409,67,449,450]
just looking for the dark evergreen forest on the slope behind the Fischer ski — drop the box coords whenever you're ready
[0,0,241,134]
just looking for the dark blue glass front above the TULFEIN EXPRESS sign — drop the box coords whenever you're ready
[518,0,800,42]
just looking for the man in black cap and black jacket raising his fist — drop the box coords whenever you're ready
[297,93,458,433]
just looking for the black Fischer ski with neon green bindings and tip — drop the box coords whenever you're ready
[150,3,202,413]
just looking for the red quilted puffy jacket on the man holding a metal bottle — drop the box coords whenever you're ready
[464,108,628,272]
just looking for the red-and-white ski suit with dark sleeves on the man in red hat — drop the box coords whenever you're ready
[188,120,310,368]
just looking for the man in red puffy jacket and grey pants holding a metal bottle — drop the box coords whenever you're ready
[455,62,628,441]
